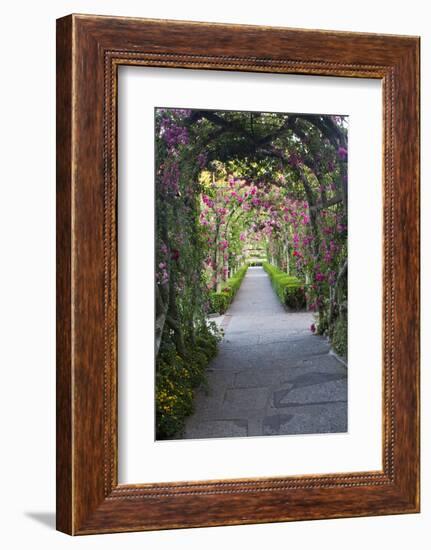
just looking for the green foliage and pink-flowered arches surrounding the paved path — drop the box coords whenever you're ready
[155,108,347,439]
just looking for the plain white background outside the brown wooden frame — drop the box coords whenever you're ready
[0,0,431,550]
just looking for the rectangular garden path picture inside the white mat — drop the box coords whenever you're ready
[154,107,349,440]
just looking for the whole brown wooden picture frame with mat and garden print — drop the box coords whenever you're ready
[57,15,419,534]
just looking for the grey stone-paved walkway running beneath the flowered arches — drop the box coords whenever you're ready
[183,267,347,439]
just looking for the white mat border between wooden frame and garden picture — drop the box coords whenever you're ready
[118,67,383,483]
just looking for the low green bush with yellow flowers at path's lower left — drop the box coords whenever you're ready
[156,326,220,439]
